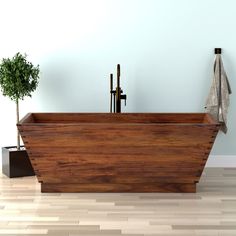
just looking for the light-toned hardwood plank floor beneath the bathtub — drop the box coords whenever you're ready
[0,168,236,236]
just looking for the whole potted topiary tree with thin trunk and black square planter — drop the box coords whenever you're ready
[0,52,39,178]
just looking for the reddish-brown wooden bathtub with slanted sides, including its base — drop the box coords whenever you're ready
[17,113,219,192]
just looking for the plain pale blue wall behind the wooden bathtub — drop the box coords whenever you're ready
[0,0,236,155]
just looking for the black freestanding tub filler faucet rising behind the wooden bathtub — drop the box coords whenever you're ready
[110,64,127,113]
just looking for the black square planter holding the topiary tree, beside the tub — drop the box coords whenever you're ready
[2,147,35,178]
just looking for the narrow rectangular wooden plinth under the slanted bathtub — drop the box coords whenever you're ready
[41,183,196,193]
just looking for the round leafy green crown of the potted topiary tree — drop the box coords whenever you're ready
[0,52,39,102]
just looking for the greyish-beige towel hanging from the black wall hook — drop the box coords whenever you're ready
[205,51,231,133]
